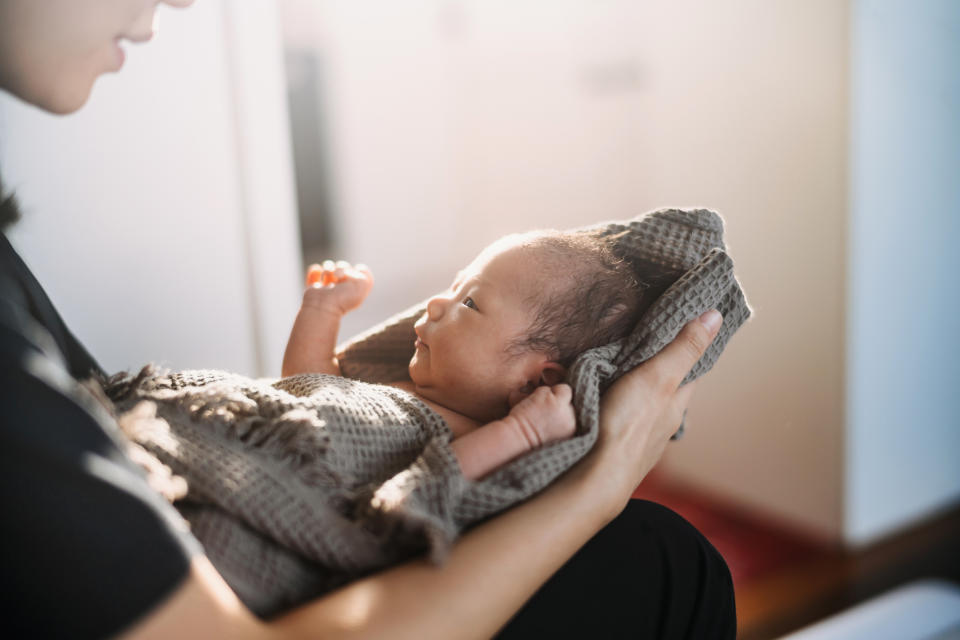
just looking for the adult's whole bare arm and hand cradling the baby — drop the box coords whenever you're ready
[122,314,719,640]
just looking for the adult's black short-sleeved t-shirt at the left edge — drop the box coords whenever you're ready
[0,233,200,638]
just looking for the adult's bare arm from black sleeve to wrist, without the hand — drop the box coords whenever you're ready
[125,456,616,640]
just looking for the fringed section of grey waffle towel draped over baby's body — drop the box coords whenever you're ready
[106,367,466,617]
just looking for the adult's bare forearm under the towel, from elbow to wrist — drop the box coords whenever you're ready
[271,452,615,640]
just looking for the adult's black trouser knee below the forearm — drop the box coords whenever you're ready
[497,500,737,640]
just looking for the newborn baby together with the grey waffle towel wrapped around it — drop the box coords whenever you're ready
[108,210,749,616]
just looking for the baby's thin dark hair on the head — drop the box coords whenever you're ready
[508,231,664,367]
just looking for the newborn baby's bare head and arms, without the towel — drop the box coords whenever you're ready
[282,231,645,480]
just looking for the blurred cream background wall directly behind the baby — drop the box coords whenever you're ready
[281,0,849,539]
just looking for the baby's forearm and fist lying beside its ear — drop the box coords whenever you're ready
[451,384,577,480]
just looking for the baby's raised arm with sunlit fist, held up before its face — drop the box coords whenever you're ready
[281,260,373,377]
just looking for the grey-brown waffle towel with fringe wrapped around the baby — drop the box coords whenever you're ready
[107,210,750,617]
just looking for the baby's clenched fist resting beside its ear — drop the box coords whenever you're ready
[504,384,577,449]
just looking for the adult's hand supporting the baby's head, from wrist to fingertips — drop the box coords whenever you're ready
[584,310,723,518]
